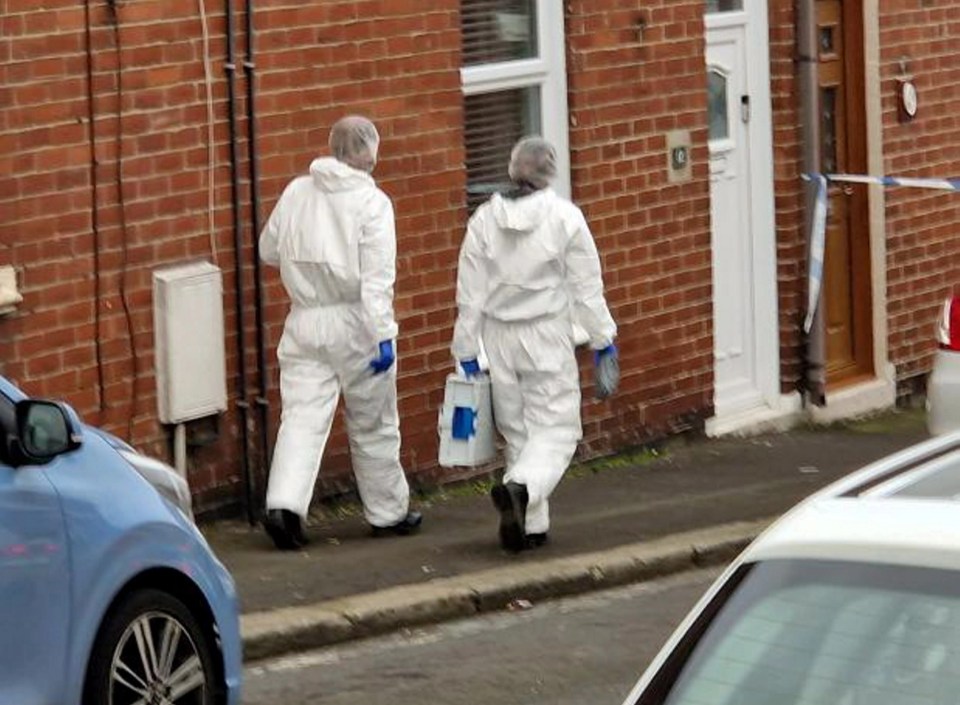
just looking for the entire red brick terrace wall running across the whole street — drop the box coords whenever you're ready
[0,0,960,508]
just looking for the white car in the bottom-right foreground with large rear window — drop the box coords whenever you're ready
[625,433,960,705]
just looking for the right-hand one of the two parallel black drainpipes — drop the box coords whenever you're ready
[243,0,270,500]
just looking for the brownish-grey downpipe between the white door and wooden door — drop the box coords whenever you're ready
[797,0,826,406]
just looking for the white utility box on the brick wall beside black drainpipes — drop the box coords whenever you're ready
[153,262,227,424]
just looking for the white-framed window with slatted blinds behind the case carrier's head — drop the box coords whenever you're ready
[460,0,570,210]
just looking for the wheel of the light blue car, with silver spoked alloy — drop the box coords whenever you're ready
[83,589,219,705]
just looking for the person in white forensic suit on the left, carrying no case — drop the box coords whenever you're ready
[260,116,422,549]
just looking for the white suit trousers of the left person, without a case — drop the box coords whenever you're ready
[266,307,410,526]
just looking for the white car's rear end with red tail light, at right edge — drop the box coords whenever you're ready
[927,294,960,435]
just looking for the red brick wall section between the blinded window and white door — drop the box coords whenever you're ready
[567,0,713,451]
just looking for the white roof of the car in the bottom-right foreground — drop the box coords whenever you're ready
[740,432,960,569]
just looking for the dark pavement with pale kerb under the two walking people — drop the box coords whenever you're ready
[203,411,926,660]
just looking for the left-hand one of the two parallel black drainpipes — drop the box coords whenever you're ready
[225,0,256,525]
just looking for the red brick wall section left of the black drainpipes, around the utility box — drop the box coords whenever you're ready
[0,0,251,506]
